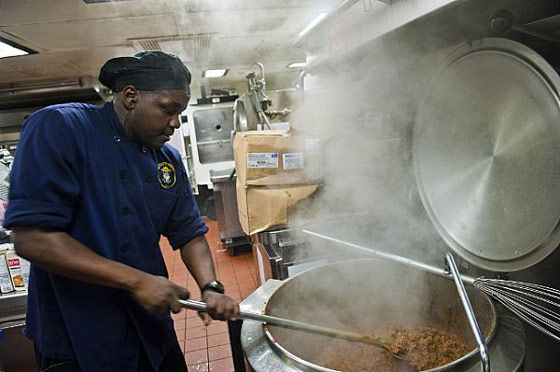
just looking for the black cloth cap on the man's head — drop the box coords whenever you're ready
[99,50,191,94]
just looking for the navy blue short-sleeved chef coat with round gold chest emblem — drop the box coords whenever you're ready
[4,103,208,372]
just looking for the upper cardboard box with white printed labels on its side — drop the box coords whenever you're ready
[233,131,320,186]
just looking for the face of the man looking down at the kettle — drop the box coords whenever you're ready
[124,90,190,149]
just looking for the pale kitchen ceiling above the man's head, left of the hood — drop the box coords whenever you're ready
[0,0,340,88]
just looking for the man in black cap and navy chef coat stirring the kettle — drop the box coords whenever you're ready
[5,52,238,372]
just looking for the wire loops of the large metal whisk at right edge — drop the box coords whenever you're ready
[473,278,560,341]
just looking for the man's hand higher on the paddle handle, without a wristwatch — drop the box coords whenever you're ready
[132,274,189,314]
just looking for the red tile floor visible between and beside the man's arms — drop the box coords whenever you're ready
[160,219,257,372]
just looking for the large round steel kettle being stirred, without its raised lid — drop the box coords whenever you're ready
[240,259,525,372]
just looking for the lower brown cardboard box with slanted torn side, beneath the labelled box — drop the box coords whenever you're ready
[237,182,319,235]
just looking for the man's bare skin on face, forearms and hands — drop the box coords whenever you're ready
[13,85,239,324]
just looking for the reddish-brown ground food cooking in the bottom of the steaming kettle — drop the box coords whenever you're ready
[306,326,469,372]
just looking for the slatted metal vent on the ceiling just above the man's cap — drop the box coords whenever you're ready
[128,34,214,63]
